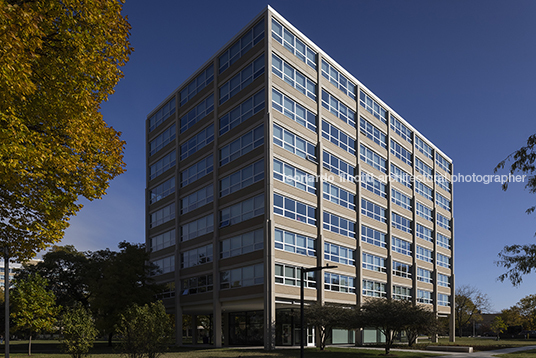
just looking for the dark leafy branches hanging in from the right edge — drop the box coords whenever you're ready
[495,134,536,286]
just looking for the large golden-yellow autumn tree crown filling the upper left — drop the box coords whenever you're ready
[0,0,132,260]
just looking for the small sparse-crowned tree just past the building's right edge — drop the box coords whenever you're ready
[454,285,491,337]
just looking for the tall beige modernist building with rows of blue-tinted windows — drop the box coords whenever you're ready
[146,7,454,347]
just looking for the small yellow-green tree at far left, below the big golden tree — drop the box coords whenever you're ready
[11,275,59,355]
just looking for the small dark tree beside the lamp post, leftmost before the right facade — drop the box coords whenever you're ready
[305,304,351,350]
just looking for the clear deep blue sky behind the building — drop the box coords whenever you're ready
[61,0,536,311]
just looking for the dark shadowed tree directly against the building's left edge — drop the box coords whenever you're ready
[87,241,162,345]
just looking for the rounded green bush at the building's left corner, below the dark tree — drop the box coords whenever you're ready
[117,301,173,358]
